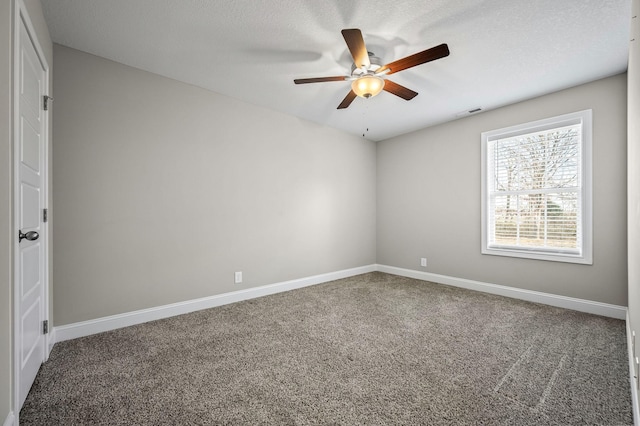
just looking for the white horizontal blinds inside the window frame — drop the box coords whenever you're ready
[487,124,582,254]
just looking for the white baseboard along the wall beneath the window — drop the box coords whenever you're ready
[377,265,627,320]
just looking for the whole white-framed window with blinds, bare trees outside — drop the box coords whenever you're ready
[482,110,592,264]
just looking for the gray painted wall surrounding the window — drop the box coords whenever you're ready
[377,74,627,306]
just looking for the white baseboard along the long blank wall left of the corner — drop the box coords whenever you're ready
[55,265,376,346]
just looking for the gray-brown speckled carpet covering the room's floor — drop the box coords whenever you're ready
[20,272,633,425]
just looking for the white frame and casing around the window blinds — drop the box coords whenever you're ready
[481,109,593,265]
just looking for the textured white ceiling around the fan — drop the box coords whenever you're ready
[42,0,631,140]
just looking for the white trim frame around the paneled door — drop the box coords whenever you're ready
[11,0,50,424]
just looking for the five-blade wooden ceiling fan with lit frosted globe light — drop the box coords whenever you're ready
[293,28,449,109]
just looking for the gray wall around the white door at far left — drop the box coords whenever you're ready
[0,0,53,422]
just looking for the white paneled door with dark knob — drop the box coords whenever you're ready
[14,10,47,409]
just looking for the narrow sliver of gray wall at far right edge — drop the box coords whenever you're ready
[627,0,640,410]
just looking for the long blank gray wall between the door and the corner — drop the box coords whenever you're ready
[53,45,376,325]
